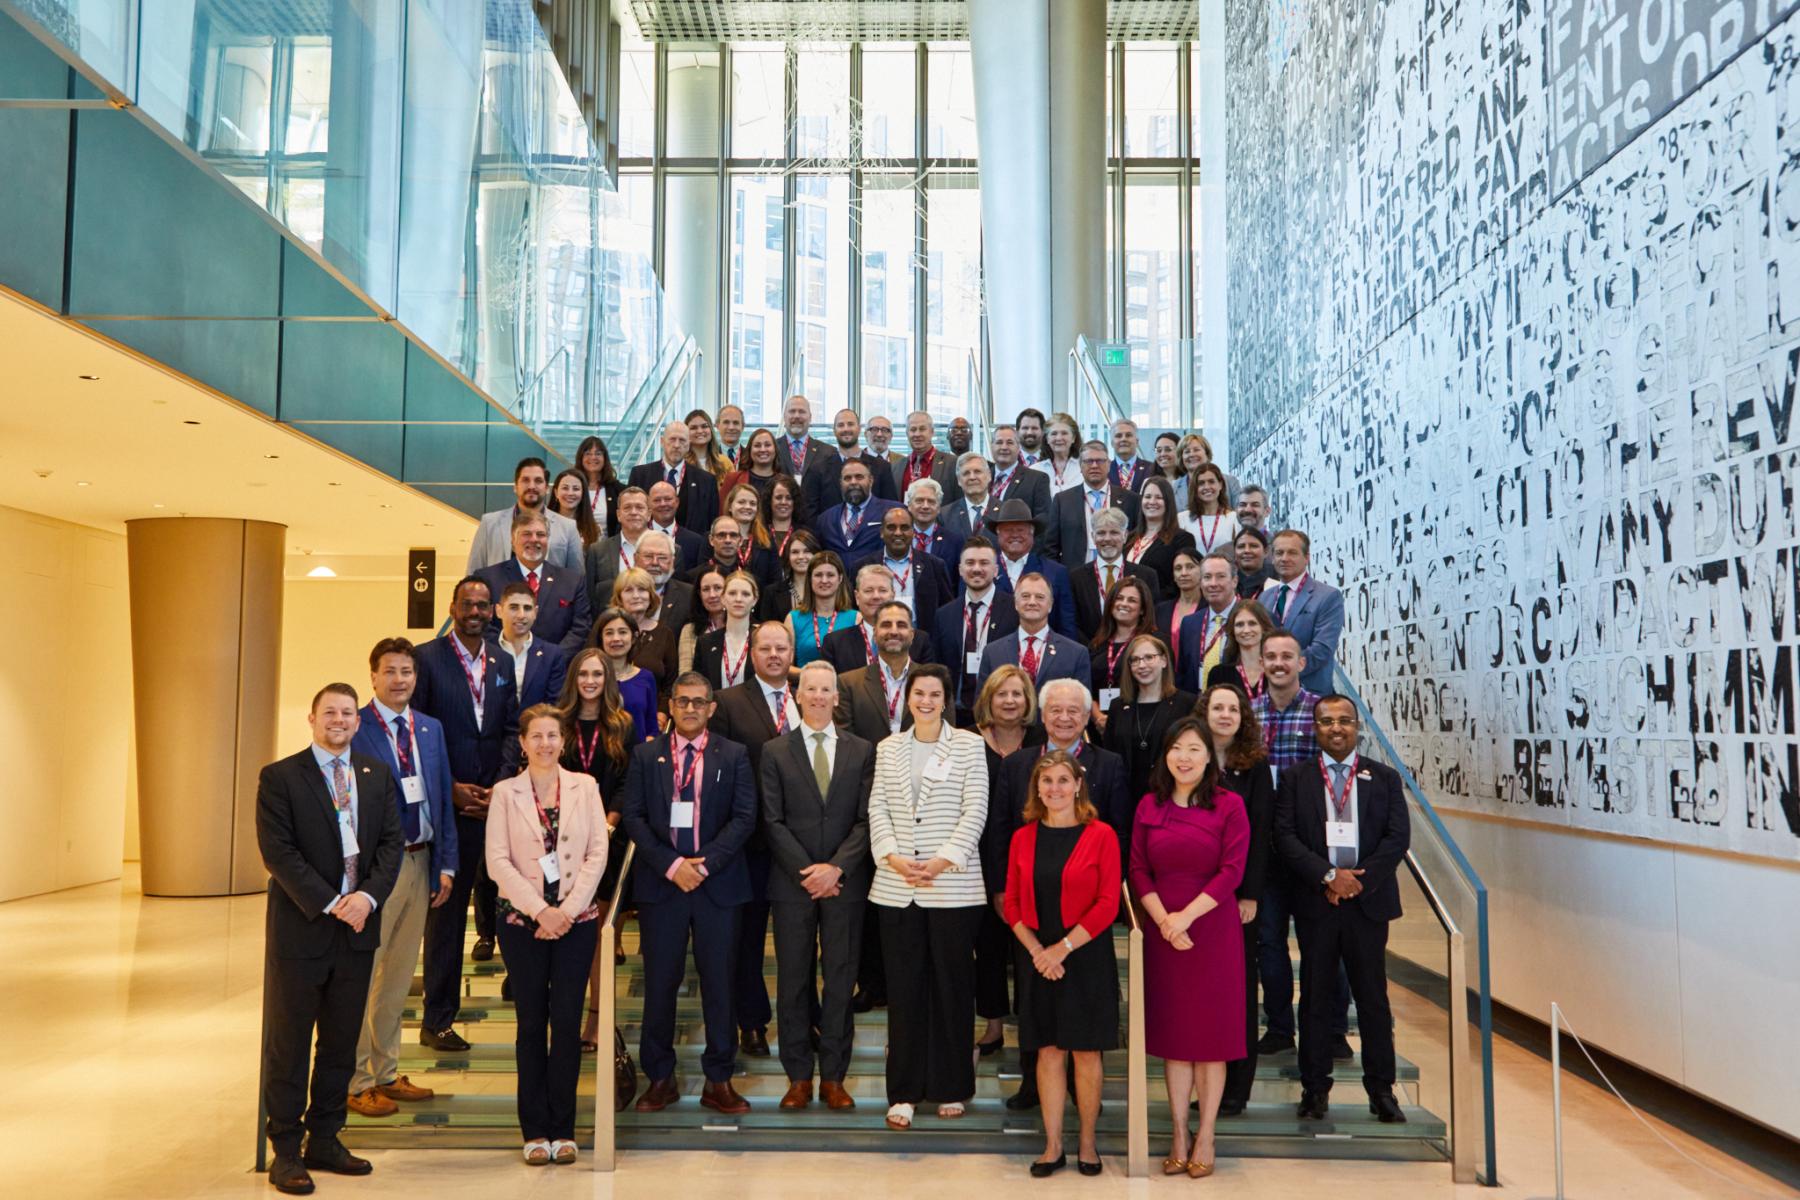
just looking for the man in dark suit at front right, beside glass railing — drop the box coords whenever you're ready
[1274,696,1411,1123]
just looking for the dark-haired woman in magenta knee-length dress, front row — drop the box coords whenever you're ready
[1130,716,1249,1178]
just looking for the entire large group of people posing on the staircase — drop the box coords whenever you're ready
[257,396,1408,1191]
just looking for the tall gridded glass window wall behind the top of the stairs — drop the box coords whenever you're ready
[619,41,1199,426]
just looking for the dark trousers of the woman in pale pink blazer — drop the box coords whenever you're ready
[497,921,599,1142]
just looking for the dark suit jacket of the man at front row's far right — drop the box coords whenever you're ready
[1274,756,1413,921]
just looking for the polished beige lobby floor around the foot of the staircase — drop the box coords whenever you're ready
[0,869,1800,1200]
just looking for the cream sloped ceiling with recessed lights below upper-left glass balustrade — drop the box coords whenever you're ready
[0,290,473,578]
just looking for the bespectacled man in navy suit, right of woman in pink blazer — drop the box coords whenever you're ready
[621,671,756,1114]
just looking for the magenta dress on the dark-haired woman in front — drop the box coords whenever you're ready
[1130,790,1249,1063]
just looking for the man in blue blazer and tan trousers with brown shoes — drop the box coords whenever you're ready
[349,637,457,1117]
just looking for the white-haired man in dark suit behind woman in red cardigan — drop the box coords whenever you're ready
[981,678,1138,1112]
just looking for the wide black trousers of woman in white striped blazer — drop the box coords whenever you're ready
[869,905,986,1105]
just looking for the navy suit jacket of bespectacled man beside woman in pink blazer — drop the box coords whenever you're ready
[619,734,756,907]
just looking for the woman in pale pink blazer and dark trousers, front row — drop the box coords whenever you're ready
[488,703,607,1166]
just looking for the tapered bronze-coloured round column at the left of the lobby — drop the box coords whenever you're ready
[126,516,286,896]
